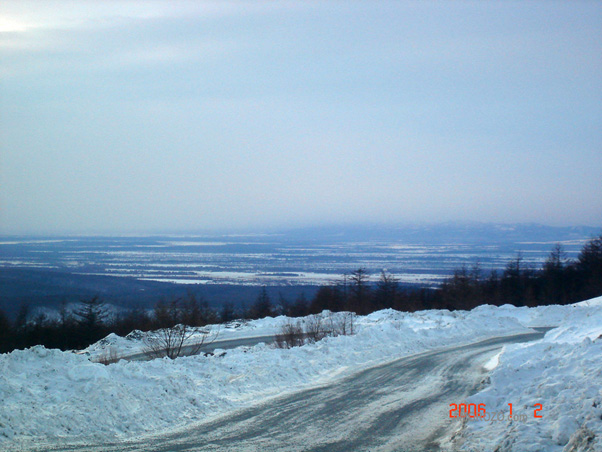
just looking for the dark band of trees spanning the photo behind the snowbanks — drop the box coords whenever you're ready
[0,235,602,352]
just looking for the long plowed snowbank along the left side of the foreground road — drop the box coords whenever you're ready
[0,307,529,450]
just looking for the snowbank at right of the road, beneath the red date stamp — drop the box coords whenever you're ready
[458,297,602,452]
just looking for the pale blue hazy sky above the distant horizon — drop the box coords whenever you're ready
[0,0,602,233]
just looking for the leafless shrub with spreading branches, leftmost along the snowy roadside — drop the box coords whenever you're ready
[144,324,217,359]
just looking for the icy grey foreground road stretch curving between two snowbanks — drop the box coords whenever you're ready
[37,333,543,452]
